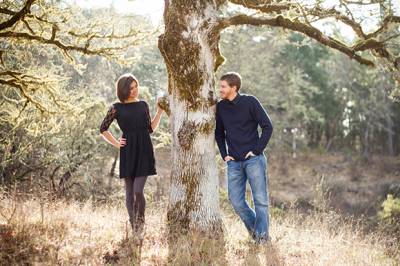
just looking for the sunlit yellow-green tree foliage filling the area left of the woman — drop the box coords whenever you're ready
[0,0,159,197]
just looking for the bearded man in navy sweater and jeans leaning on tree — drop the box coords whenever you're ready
[215,72,273,244]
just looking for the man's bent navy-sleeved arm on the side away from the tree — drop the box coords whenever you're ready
[250,96,273,155]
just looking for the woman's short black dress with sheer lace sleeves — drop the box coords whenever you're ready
[100,100,157,178]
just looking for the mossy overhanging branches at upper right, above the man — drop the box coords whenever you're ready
[222,0,400,86]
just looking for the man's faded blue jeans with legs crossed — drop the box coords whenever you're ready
[227,153,269,240]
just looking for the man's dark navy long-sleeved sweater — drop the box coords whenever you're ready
[215,93,273,161]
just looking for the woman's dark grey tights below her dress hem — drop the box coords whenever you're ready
[124,176,147,225]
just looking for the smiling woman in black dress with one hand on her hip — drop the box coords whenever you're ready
[100,73,162,231]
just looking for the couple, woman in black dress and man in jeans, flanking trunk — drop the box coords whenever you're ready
[100,72,272,244]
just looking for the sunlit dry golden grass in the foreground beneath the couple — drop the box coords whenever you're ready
[0,188,396,265]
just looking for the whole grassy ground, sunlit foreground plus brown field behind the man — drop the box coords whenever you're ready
[0,151,400,265]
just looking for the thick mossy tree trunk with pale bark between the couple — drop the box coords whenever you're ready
[158,1,222,232]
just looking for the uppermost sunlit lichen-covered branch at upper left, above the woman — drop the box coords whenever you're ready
[0,0,153,66]
